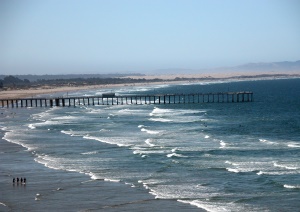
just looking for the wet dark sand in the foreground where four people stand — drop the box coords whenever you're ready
[0,126,204,212]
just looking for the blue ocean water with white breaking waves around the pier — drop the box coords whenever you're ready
[1,79,300,211]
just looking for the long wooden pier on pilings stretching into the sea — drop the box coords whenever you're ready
[0,91,253,108]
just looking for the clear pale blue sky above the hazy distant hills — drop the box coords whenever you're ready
[0,0,300,75]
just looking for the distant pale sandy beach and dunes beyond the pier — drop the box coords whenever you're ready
[0,73,300,99]
